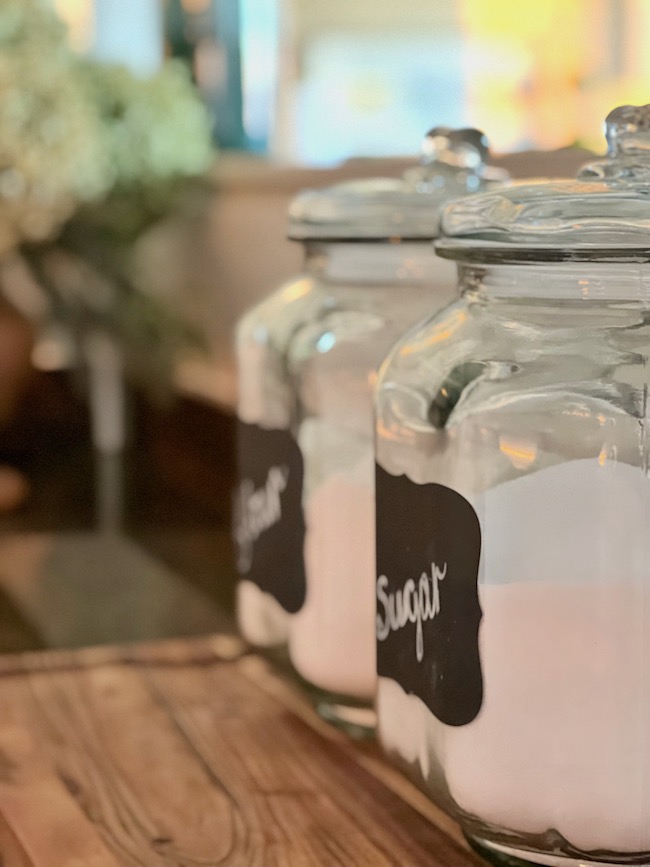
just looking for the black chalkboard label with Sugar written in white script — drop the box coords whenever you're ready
[376,466,483,726]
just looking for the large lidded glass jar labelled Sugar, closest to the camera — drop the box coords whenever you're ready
[376,106,650,867]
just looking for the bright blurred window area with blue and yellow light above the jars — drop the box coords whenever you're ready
[56,0,650,159]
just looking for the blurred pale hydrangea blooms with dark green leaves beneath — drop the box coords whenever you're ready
[0,0,214,390]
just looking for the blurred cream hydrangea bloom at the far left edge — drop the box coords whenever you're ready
[0,0,112,252]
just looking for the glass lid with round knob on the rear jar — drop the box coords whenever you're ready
[289,127,508,241]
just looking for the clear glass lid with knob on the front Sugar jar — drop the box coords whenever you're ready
[436,105,650,262]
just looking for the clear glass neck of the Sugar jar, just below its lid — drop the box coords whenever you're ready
[458,262,650,307]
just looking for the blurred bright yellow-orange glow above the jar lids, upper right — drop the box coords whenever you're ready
[460,0,600,150]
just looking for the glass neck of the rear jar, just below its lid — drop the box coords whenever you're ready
[305,240,446,286]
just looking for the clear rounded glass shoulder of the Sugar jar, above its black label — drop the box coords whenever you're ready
[375,301,650,474]
